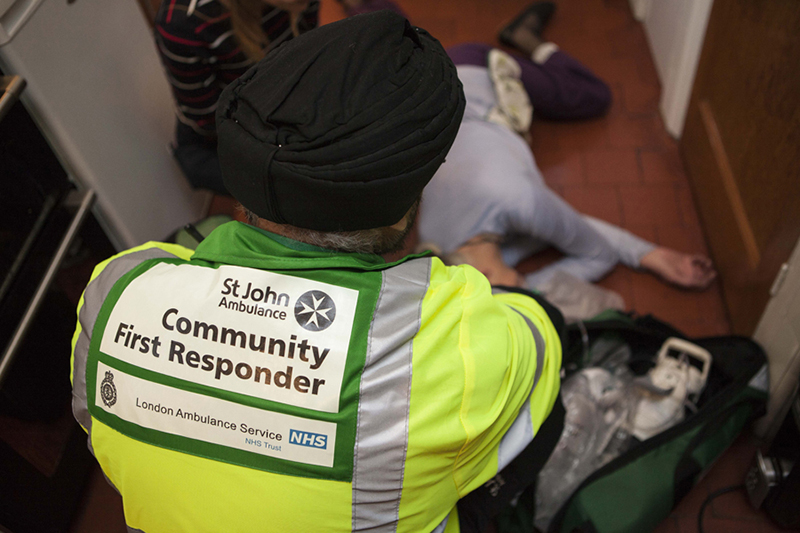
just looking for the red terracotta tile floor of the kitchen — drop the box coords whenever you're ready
[72,0,779,533]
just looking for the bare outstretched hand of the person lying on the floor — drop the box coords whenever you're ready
[639,247,717,289]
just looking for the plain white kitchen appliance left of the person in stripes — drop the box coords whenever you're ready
[0,0,208,248]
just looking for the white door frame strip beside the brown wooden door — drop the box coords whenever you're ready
[630,0,713,137]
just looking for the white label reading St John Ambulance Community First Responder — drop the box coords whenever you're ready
[100,263,358,413]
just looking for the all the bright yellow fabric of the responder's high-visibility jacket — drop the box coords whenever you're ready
[73,243,561,533]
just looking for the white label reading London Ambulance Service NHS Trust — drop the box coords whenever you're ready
[95,363,336,467]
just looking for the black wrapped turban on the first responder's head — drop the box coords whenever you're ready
[217,11,464,231]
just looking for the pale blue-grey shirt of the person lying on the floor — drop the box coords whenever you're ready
[419,66,655,288]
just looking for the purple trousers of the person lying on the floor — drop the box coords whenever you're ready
[447,43,611,120]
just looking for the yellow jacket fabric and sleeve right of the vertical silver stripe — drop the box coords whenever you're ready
[398,259,561,532]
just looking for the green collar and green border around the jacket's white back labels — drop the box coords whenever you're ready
[87,223,395,482]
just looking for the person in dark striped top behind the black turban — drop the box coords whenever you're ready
[155,0,403,195]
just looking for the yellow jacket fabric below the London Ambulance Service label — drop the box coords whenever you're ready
[92,420,352,533]
